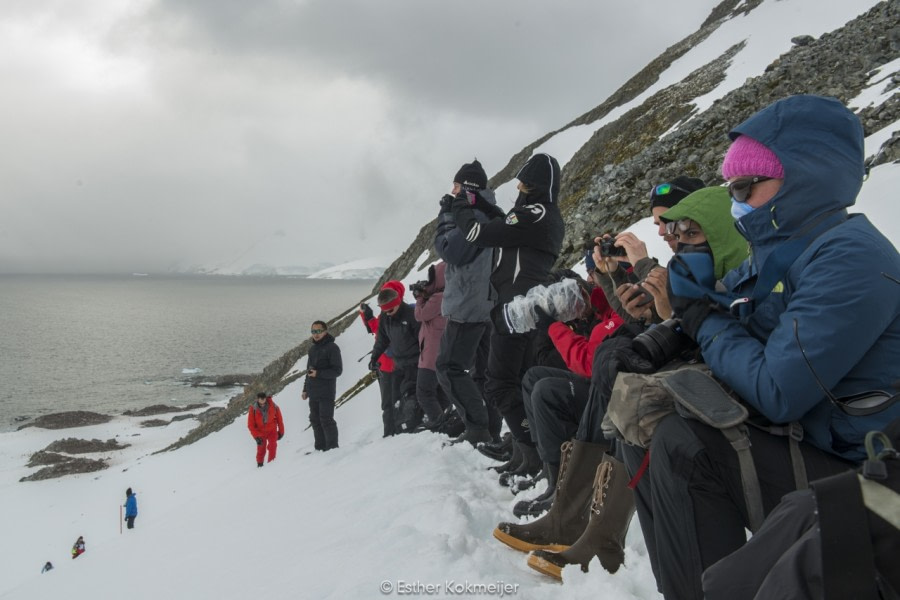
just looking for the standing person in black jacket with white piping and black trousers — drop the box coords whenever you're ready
[452,154,565,472]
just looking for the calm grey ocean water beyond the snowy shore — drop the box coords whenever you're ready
[0,275,373,431]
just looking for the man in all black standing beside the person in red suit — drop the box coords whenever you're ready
[301,321,344,450]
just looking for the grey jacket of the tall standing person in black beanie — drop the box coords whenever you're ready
[434,189,497,323]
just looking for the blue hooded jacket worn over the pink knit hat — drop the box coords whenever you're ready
[697,95,900,460]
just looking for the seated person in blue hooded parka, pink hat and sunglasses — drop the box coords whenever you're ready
[637,95,900,600]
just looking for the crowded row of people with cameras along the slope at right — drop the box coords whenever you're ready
[361,95,900,599]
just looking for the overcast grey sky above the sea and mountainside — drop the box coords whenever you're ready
[0,0,717,273]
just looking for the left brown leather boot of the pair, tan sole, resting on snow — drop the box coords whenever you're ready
[494,441,608,552]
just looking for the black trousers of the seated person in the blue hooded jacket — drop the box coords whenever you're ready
[623,414,853,600]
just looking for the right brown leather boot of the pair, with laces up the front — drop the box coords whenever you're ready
[528,454,634,581]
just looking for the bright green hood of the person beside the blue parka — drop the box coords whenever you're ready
[660,186,750,279]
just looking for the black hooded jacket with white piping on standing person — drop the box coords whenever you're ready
[452,154,565,304]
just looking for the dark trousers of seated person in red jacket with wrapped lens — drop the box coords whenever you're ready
[522,366,591,465]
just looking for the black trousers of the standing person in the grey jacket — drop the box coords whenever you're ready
[435,321,489,430]
